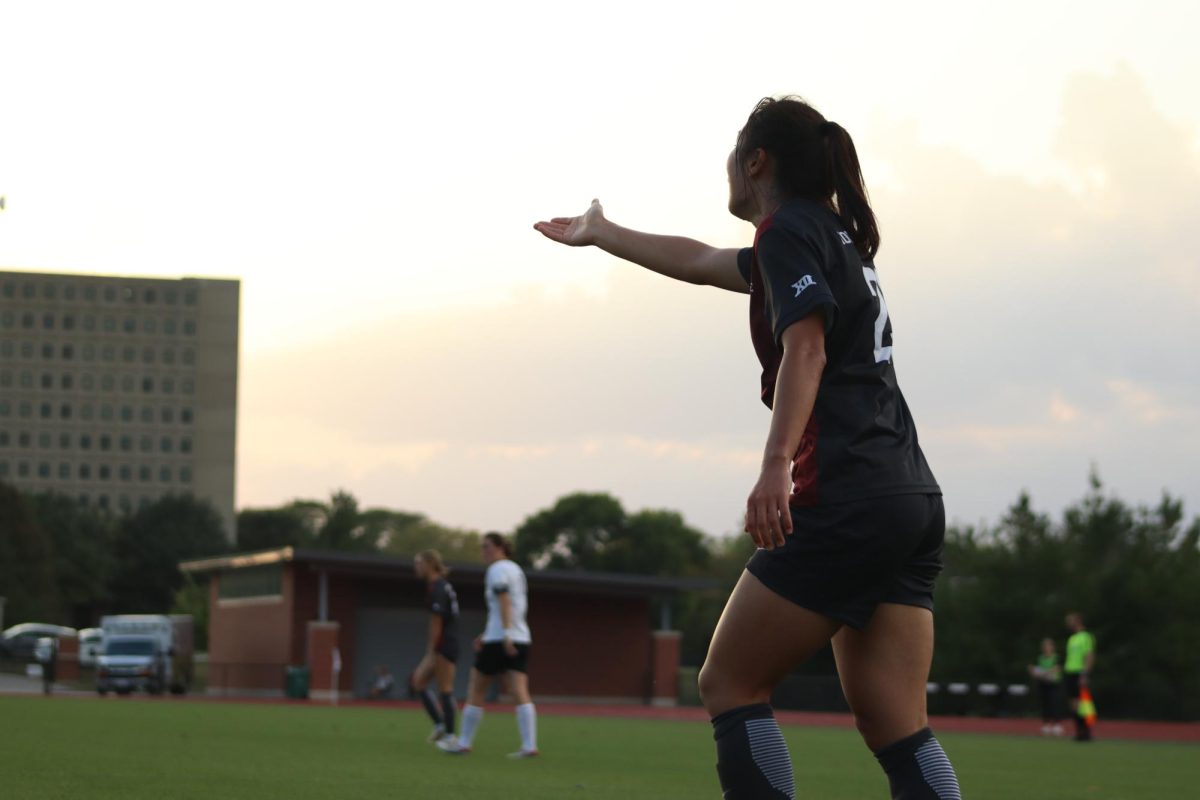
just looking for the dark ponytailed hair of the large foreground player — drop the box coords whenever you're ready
[734,97,880,259]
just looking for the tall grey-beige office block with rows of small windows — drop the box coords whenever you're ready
[0,271,240,540]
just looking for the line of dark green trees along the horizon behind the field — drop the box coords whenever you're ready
[0,475,1200,720]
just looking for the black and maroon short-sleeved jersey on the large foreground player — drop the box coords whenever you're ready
[738,200,941,506]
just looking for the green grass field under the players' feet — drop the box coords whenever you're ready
[0,696,1200,800]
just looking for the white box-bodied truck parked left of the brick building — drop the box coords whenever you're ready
[96,614,192,694]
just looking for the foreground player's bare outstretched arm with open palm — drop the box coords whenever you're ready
[534,200,750,294]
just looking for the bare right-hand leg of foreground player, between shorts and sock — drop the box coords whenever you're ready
[833,603,934,751]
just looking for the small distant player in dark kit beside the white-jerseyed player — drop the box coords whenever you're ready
[413,551,458,742]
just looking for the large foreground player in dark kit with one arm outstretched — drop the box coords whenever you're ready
[534,97,960,800]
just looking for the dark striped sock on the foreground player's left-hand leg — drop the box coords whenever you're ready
[713,703,796,800]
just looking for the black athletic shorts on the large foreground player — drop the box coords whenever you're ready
[746,494,946,630]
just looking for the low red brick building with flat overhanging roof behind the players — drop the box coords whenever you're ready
[180,547,709,704]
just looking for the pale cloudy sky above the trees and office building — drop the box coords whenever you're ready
[0,0,1200,534]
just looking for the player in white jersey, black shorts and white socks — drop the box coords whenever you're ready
[438,534,538,758]
